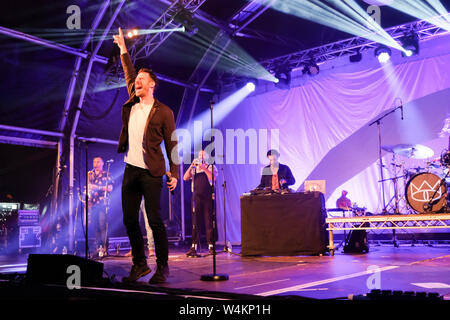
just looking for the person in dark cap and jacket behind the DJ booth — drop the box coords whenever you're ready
[257,149,295,190]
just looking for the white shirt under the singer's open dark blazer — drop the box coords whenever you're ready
[124,102,153,169]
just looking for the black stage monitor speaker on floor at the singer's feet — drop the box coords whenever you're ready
[26,254,103,286]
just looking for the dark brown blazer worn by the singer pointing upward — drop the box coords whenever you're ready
[117,53,179,179]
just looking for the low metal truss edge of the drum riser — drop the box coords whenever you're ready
[325,213,450,255]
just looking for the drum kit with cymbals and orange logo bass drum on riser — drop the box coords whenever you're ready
[380,144,450,213]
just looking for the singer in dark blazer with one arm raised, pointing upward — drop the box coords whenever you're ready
[114,28,179,284]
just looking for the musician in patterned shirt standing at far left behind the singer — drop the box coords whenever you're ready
[88,156,113,258]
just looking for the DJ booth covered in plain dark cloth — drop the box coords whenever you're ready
[241,192,328,256]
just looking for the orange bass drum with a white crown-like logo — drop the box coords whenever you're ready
[405,172,447,212]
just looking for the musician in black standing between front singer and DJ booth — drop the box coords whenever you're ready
[183,150,217,257]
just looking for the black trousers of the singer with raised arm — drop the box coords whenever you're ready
[122,164,169,265]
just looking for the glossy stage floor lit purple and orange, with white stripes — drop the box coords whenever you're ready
[0,244,450,300]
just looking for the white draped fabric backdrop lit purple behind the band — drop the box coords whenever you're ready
[213,36,450,243]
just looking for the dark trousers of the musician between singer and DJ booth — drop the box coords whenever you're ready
[192,192,214,244]
